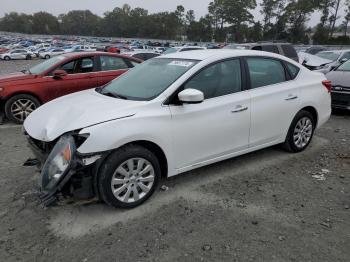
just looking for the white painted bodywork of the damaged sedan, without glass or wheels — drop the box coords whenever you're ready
[24,50,331,176]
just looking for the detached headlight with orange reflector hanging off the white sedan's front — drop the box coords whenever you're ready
[41,135,76,191]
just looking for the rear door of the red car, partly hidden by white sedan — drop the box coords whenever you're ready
[98,55,132,86]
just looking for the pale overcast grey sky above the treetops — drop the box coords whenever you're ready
[0,0,344,26]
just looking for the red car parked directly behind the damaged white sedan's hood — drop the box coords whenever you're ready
[0,52,142,123]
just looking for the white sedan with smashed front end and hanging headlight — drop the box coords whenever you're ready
[24,50,331,208]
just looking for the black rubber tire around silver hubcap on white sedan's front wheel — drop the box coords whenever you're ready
[97,144,161,208]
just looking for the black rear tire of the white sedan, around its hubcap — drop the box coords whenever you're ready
[283,110,316,153]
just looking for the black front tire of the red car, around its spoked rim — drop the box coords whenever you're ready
[5,94,40,124]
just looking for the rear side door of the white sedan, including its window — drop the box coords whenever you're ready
[245,57,300,147]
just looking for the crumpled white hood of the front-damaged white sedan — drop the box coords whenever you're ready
[24,89,146,142]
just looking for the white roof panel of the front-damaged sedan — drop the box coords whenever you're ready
[158,49,290,61]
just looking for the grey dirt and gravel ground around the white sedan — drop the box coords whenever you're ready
[0,59,350,262]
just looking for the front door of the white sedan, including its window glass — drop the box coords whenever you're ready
[170,59,250,172]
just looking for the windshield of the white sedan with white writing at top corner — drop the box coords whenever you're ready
[100,58,198,101]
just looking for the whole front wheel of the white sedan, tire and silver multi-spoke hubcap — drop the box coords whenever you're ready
[98,145,161,208]
